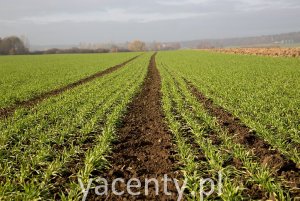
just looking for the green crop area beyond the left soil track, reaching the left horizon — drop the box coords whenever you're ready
[0,53,137,108]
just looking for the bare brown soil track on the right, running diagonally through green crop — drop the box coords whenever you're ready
[186,81,300,196]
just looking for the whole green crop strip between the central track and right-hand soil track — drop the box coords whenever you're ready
[157,53,298,200]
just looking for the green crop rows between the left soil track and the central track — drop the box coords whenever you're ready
[0,54,150,200]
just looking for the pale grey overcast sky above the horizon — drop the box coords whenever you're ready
[0,0,300,45]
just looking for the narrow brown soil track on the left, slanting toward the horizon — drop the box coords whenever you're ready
[0,55,140,119]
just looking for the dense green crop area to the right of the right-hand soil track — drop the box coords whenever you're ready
[156,51,300,167]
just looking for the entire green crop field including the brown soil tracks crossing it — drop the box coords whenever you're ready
[0,51,300,200]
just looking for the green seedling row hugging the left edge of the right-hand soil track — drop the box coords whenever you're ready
[157,62,290,200]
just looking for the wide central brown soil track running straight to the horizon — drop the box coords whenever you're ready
[91,54,181,200]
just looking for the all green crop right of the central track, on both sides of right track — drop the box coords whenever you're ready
[157,51,300,200]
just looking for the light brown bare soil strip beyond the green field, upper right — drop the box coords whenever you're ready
[211,48,300,57]
